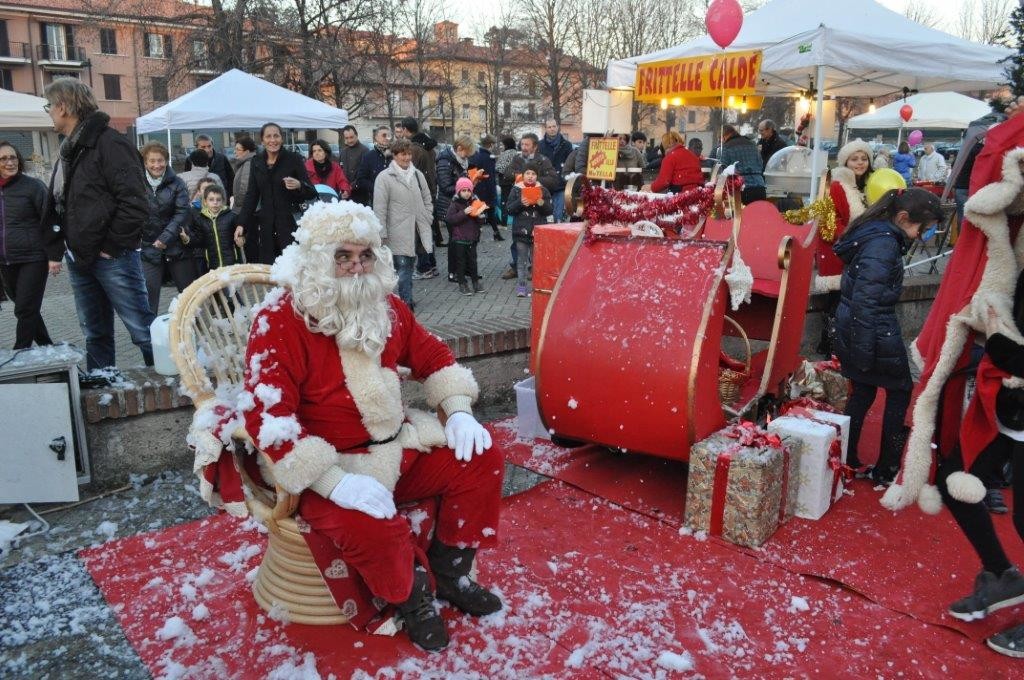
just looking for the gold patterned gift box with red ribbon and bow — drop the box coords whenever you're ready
[684,424,799,548]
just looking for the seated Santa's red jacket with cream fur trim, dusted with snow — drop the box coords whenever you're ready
[243,293,478,496]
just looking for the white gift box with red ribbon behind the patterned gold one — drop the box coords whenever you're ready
[768,412,849,519]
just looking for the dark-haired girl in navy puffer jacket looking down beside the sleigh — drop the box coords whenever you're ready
[833,188,943,483]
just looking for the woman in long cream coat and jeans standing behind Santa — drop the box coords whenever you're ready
[374,139,434,310]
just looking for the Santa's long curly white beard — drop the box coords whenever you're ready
[293,250,397,354]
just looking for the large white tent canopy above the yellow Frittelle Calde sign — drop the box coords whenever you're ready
[607,0,1012,96]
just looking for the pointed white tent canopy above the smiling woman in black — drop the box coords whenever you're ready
[135,69,348,134]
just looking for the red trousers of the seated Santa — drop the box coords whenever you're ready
[299,445,505,603]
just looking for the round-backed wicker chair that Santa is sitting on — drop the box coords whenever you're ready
[170,264,348,625]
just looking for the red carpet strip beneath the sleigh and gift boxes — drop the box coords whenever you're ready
[496,413,1024,647]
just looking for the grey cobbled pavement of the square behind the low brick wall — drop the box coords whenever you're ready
[0,228,530,368]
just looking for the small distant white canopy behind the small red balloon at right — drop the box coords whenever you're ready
[846,92,992,130]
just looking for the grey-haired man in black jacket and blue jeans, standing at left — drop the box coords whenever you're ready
[43,78,154,371]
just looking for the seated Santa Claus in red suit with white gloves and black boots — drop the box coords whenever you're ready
[246,202,504,650]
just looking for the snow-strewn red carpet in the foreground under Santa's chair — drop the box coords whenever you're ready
[81,481,1020,679]
